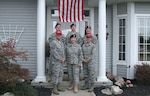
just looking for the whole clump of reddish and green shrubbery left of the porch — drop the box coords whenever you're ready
[0,39,38,96]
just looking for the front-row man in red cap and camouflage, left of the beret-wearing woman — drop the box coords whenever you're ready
[50,31,65,95]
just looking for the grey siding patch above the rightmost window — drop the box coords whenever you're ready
[135,2,150,14]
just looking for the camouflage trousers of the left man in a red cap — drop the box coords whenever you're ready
[51,62,64,85]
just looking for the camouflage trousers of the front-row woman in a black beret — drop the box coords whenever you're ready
[67,64,80,84]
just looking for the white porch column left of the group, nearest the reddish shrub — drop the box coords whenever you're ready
[34,0,46,82]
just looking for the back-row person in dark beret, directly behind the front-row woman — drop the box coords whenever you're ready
[66,24,83,45]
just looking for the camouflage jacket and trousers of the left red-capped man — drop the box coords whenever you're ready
[50,40,65,85]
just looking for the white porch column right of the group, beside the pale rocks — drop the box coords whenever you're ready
[97,0,109,82]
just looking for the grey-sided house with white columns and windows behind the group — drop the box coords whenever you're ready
[0,0,150,82]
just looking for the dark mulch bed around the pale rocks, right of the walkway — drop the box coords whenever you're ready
[94,85,150,96]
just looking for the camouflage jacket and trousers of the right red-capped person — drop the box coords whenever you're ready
[82,42,96,89]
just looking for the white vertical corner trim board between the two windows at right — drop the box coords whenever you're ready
[126,2,138,79]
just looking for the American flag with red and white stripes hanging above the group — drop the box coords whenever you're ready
[58,0,84,22]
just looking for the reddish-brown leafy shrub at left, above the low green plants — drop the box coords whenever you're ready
[0,39,29,86]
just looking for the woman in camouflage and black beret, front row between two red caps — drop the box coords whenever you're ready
[66,34,83,93]
